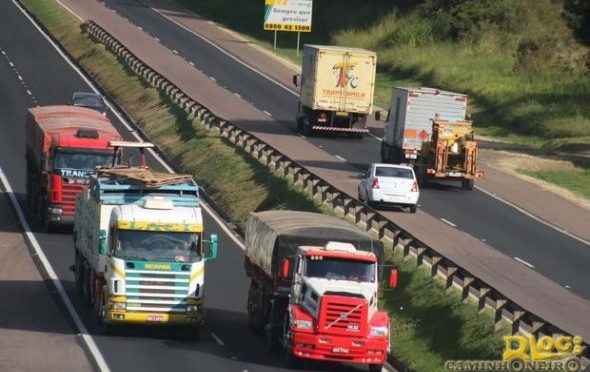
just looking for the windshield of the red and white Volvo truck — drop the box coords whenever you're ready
[305,257,375,282]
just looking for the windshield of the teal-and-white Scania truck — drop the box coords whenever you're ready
[115,230,201,262]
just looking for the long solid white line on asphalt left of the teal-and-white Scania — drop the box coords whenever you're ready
[0,168,110,372]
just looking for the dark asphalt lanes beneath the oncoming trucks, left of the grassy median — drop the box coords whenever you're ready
[0,1,380,371]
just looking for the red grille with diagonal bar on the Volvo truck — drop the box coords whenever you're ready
[319,295,369,336]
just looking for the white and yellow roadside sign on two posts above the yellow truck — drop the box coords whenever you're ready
[264,0,313,57]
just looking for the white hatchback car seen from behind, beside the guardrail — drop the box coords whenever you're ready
[358,163,420,213]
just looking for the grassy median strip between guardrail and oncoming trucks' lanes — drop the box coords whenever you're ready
[22,0,502,371]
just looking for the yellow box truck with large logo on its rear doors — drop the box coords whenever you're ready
[293,45,377,138]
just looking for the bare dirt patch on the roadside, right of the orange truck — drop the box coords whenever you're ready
[480,149,590,210]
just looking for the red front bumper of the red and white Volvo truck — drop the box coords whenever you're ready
[291,332,389,364]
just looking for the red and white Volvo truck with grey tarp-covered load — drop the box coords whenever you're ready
[245,211,397,371]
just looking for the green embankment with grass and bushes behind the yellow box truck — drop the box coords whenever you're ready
[177,0,590,198]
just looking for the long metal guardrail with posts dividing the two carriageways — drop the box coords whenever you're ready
[81,21,590,364]
